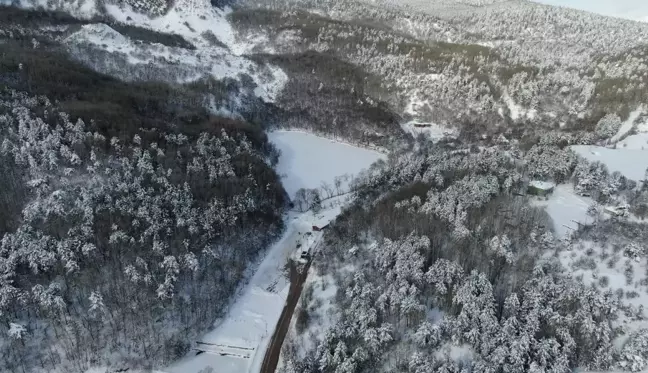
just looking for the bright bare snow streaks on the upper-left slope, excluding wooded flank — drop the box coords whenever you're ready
[62,0,288,102]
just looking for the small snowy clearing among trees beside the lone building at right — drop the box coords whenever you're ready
[533,184,595,237]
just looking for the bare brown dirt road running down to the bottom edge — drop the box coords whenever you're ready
[261,259,312,373]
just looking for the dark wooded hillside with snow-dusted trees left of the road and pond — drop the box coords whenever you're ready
[0,18,287,372]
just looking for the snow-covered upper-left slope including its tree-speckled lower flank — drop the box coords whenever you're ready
[50,0,288,102]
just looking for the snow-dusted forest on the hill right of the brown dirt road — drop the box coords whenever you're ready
[283,140,648,373]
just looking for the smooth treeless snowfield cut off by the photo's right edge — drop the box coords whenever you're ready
[571,145,648,180]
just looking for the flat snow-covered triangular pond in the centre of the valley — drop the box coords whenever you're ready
[268,131,386,197]
